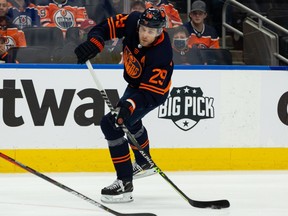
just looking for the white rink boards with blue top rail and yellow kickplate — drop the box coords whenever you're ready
[0,65,288,172]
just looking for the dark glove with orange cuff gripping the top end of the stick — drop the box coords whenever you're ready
[74,38,104,64]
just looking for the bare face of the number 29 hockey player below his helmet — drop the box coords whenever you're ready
[139,25,158,47]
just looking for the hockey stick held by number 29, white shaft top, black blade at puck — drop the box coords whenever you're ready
[86,60,230,209]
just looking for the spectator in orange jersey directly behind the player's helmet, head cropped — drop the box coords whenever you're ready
[145,0,183,28]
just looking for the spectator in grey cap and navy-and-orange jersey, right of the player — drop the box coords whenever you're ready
[184,0,220,48]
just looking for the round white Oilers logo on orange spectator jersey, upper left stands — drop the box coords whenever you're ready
[53,9,75,30]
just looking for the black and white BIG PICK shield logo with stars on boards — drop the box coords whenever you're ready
[158,86,215,131]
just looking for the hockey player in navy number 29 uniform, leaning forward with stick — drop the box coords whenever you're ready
[75,8,174,203]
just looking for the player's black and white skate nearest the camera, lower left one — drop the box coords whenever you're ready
[101,179,133,203]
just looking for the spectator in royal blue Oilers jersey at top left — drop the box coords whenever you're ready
[7,0,40,29]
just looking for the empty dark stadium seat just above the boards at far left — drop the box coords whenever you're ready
[8,46,51,63]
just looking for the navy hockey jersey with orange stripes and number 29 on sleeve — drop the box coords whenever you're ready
[88,12,174,106]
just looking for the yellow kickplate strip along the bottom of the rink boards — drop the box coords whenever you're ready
[0,148,288,172]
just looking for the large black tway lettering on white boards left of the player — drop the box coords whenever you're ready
[0,80,119,127]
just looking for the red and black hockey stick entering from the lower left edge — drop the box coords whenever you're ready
[0,152,156,216]
